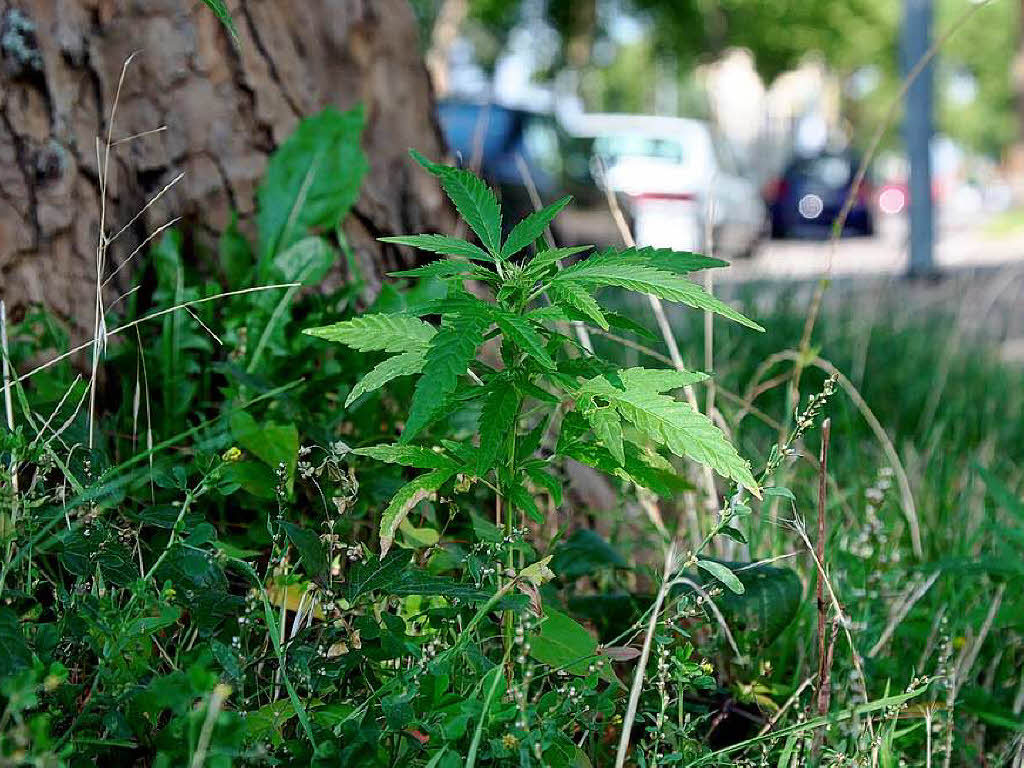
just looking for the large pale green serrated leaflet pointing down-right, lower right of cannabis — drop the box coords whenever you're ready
[582,377,760,496]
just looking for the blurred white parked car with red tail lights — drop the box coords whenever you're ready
[566,114,765,257]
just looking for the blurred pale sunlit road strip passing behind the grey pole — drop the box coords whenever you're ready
[716,216,1024,281]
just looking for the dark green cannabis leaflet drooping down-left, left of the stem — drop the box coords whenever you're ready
[401,315,490,442]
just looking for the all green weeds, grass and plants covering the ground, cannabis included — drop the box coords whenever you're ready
[0,105,1024,768]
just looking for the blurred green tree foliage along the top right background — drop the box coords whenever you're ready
[413,0,1021,155]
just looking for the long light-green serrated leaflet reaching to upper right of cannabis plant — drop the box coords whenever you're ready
[551,256,764,331]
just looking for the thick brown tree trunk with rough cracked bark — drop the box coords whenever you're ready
[0,0,449,338]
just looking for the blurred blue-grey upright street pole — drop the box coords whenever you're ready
[900,0,935,278]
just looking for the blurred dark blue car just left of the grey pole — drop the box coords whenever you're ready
[764,152,874,238]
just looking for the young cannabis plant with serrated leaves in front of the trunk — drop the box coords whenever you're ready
[306,152,762,569]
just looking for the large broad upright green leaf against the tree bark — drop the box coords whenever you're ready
[257,106,370,259]
